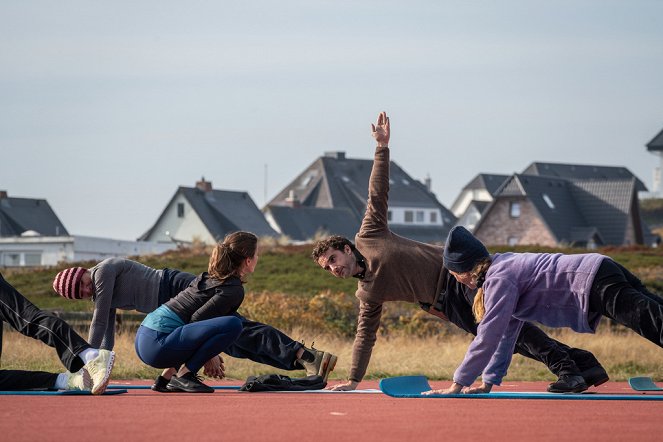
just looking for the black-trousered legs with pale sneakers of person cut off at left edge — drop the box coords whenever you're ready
[0,274,114,394]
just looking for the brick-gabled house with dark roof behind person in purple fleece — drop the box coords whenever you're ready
[474,171,648,248]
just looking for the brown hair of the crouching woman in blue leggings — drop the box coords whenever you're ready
[207,231,258,282]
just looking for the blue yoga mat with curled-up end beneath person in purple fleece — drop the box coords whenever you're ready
[380,376,663,401]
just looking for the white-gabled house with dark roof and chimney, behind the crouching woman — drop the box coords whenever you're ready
[139,177,277,245]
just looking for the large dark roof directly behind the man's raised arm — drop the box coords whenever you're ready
[266,152,456,242]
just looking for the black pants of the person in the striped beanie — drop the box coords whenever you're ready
[159,269,303,370]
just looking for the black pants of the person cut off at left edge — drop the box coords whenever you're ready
[0,274,90,390]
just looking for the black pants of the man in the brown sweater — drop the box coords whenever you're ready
[435,275,600,376]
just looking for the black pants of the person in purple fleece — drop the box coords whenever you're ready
[588,259,663,347]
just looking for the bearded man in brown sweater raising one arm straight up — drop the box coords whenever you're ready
[312,112,608,393]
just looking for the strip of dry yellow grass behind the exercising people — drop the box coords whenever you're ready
[2,327,663,381]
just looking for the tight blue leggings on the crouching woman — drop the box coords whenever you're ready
[136,316,242,373]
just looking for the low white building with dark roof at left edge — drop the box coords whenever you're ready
[0,191,175,267]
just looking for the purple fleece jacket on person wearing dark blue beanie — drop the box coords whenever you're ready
[454,253,609,386]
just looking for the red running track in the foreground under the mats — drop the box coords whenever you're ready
[0,381,663,442]
